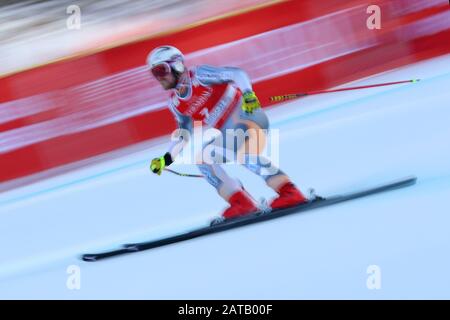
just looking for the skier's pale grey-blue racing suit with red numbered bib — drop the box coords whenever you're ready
[168,65,288,200]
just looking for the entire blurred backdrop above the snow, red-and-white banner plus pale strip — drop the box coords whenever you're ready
[0,0,449,190]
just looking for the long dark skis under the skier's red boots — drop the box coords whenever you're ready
[81,176,417,261]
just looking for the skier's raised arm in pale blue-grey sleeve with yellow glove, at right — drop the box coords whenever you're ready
[195,65,261,113]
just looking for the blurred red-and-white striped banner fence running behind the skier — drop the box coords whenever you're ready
[0,0,450,186]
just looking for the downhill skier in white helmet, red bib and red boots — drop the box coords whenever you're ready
[147,46,308,219]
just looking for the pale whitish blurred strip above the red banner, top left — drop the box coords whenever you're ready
[0,0,270,74]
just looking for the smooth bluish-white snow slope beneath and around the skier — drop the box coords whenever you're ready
[0,55,450,299]
